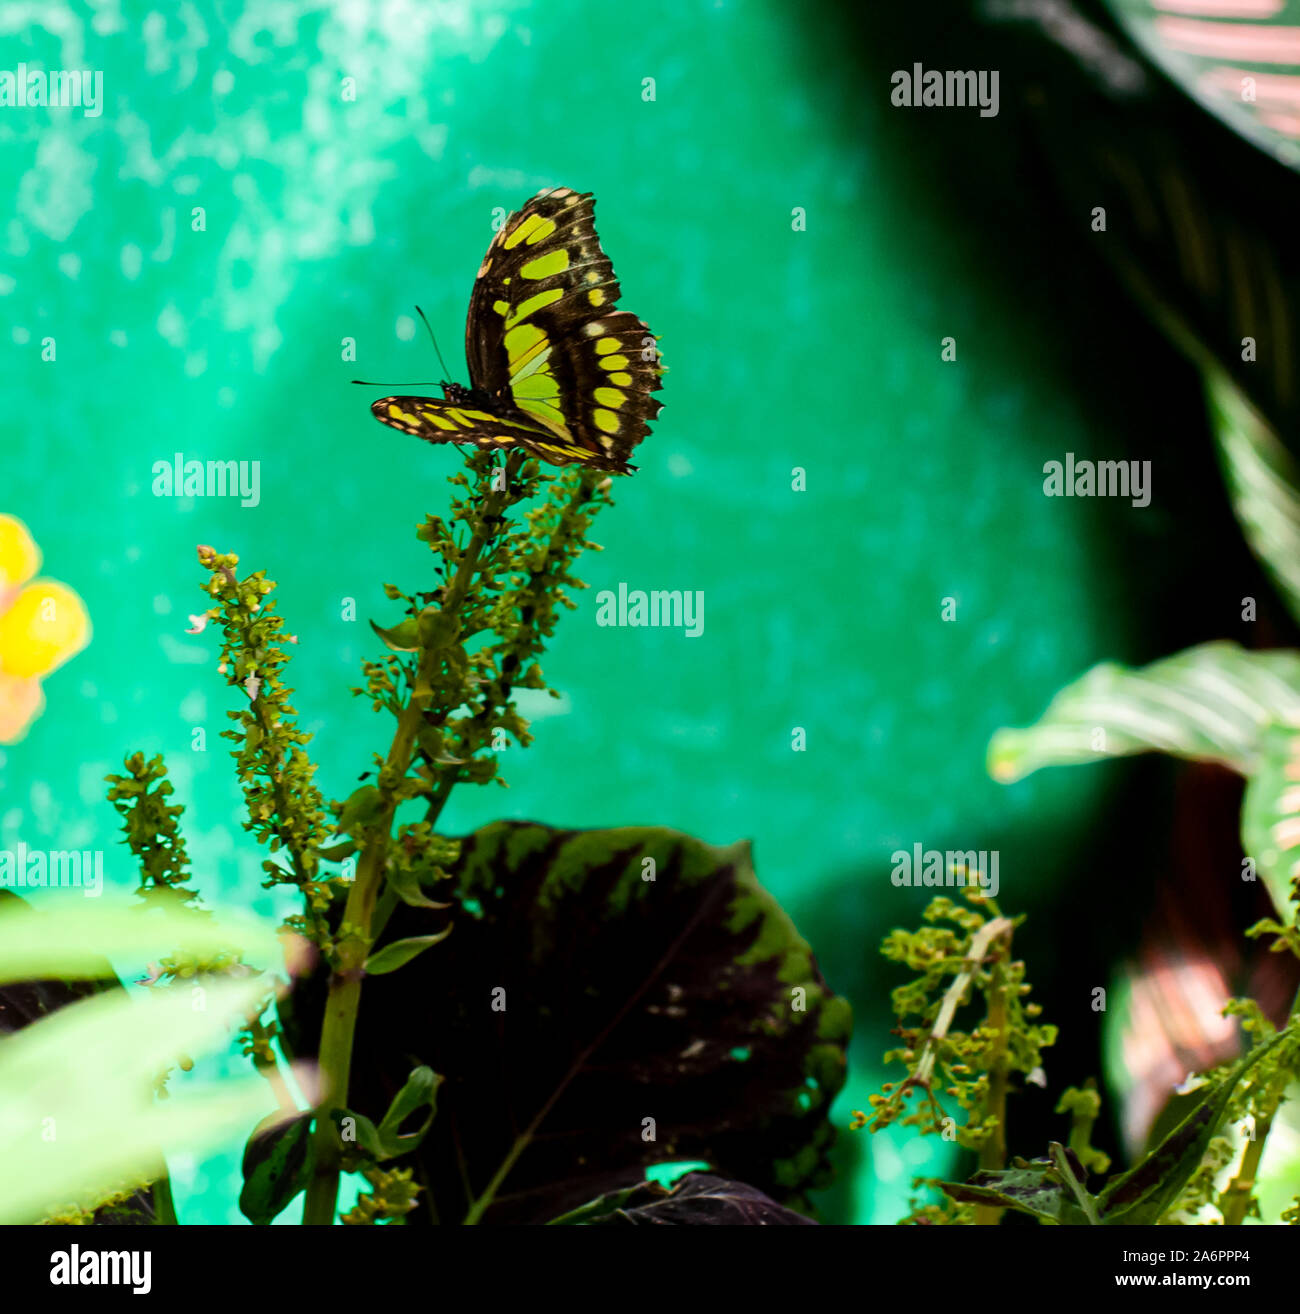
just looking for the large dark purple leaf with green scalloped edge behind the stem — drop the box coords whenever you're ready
[310,823,849,1223]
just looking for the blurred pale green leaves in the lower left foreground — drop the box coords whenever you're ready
[0,895,279,1223]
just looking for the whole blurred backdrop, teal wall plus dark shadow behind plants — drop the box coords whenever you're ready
[0,0,1300,1222]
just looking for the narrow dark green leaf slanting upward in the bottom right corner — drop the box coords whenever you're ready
[1098,1031,1288,1226]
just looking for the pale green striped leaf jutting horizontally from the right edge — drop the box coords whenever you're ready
[988,643,1300,783]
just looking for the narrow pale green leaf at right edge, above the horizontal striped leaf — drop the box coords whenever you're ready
[1205,369,1300,620]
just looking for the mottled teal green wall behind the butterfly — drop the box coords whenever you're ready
[0,0,1219,1221]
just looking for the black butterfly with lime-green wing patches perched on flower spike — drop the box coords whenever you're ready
[371,187,664,474]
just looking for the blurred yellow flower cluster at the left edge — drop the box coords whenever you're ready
[0,515,91,744]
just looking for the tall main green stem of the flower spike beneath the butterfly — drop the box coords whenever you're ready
[302,452,526,1226]
